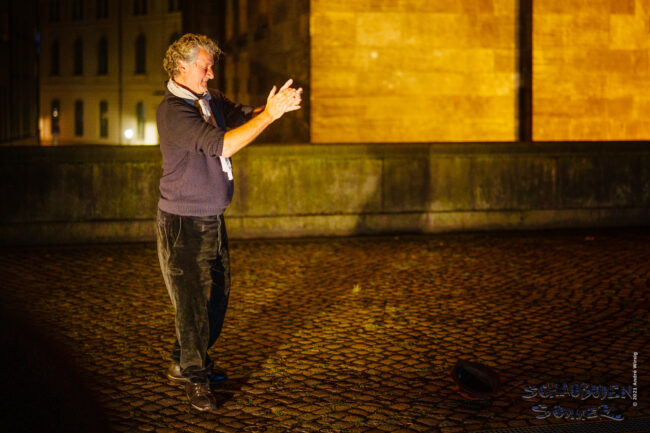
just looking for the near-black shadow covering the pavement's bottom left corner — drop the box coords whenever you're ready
[0,308,110,433]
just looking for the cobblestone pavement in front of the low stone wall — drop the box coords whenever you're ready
[0,229,650,433]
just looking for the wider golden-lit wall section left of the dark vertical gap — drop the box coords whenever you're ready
[310,0,517,143]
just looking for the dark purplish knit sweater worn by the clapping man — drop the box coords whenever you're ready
[156,89,253,216]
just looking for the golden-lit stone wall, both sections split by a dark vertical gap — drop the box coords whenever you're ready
[310,0,650,143]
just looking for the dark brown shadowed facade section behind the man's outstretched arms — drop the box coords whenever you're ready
[220,0,311,143]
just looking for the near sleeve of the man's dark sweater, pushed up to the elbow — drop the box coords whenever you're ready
[156,98,226,158]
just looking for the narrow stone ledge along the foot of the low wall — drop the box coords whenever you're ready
[0,208,650,246]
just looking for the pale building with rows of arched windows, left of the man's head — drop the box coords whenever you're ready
[39,0,181,145]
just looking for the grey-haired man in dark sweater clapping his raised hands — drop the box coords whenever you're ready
[156,33,302,411]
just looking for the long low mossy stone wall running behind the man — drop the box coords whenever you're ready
[0,142,650,244]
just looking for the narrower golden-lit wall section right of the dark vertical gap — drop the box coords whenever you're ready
[533,0,650,141]
